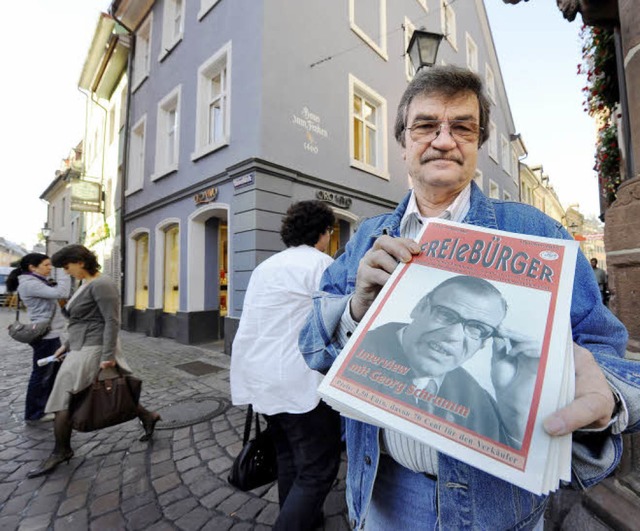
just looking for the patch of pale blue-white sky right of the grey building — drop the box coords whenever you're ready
[485,0,600,216]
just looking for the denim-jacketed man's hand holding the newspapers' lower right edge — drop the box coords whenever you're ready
[544,343,615,435]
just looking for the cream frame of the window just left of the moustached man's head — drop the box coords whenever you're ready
[348,74,389,180]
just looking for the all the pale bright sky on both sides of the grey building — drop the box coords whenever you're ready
[0,0,599,248]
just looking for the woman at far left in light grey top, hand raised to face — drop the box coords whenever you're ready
[7,253,71,422]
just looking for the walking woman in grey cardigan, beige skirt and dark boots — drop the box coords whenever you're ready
[28,245,160,477]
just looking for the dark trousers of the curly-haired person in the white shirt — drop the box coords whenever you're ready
[266,402,342,531]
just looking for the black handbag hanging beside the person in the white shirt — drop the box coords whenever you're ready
[227,405,278,491]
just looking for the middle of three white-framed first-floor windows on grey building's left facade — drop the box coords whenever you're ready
[151,85,182,180]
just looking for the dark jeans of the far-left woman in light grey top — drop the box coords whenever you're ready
[24,337,60,420]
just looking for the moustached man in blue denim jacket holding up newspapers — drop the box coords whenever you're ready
[300,66,640,529]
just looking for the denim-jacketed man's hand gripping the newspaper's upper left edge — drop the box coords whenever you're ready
[350,236,420,321]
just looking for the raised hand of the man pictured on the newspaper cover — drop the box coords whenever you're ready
[491,327,541,442]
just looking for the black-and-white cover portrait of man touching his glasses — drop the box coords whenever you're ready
[358,275,541,449]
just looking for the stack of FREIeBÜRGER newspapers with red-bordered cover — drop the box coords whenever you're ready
[318,220,578,494]
